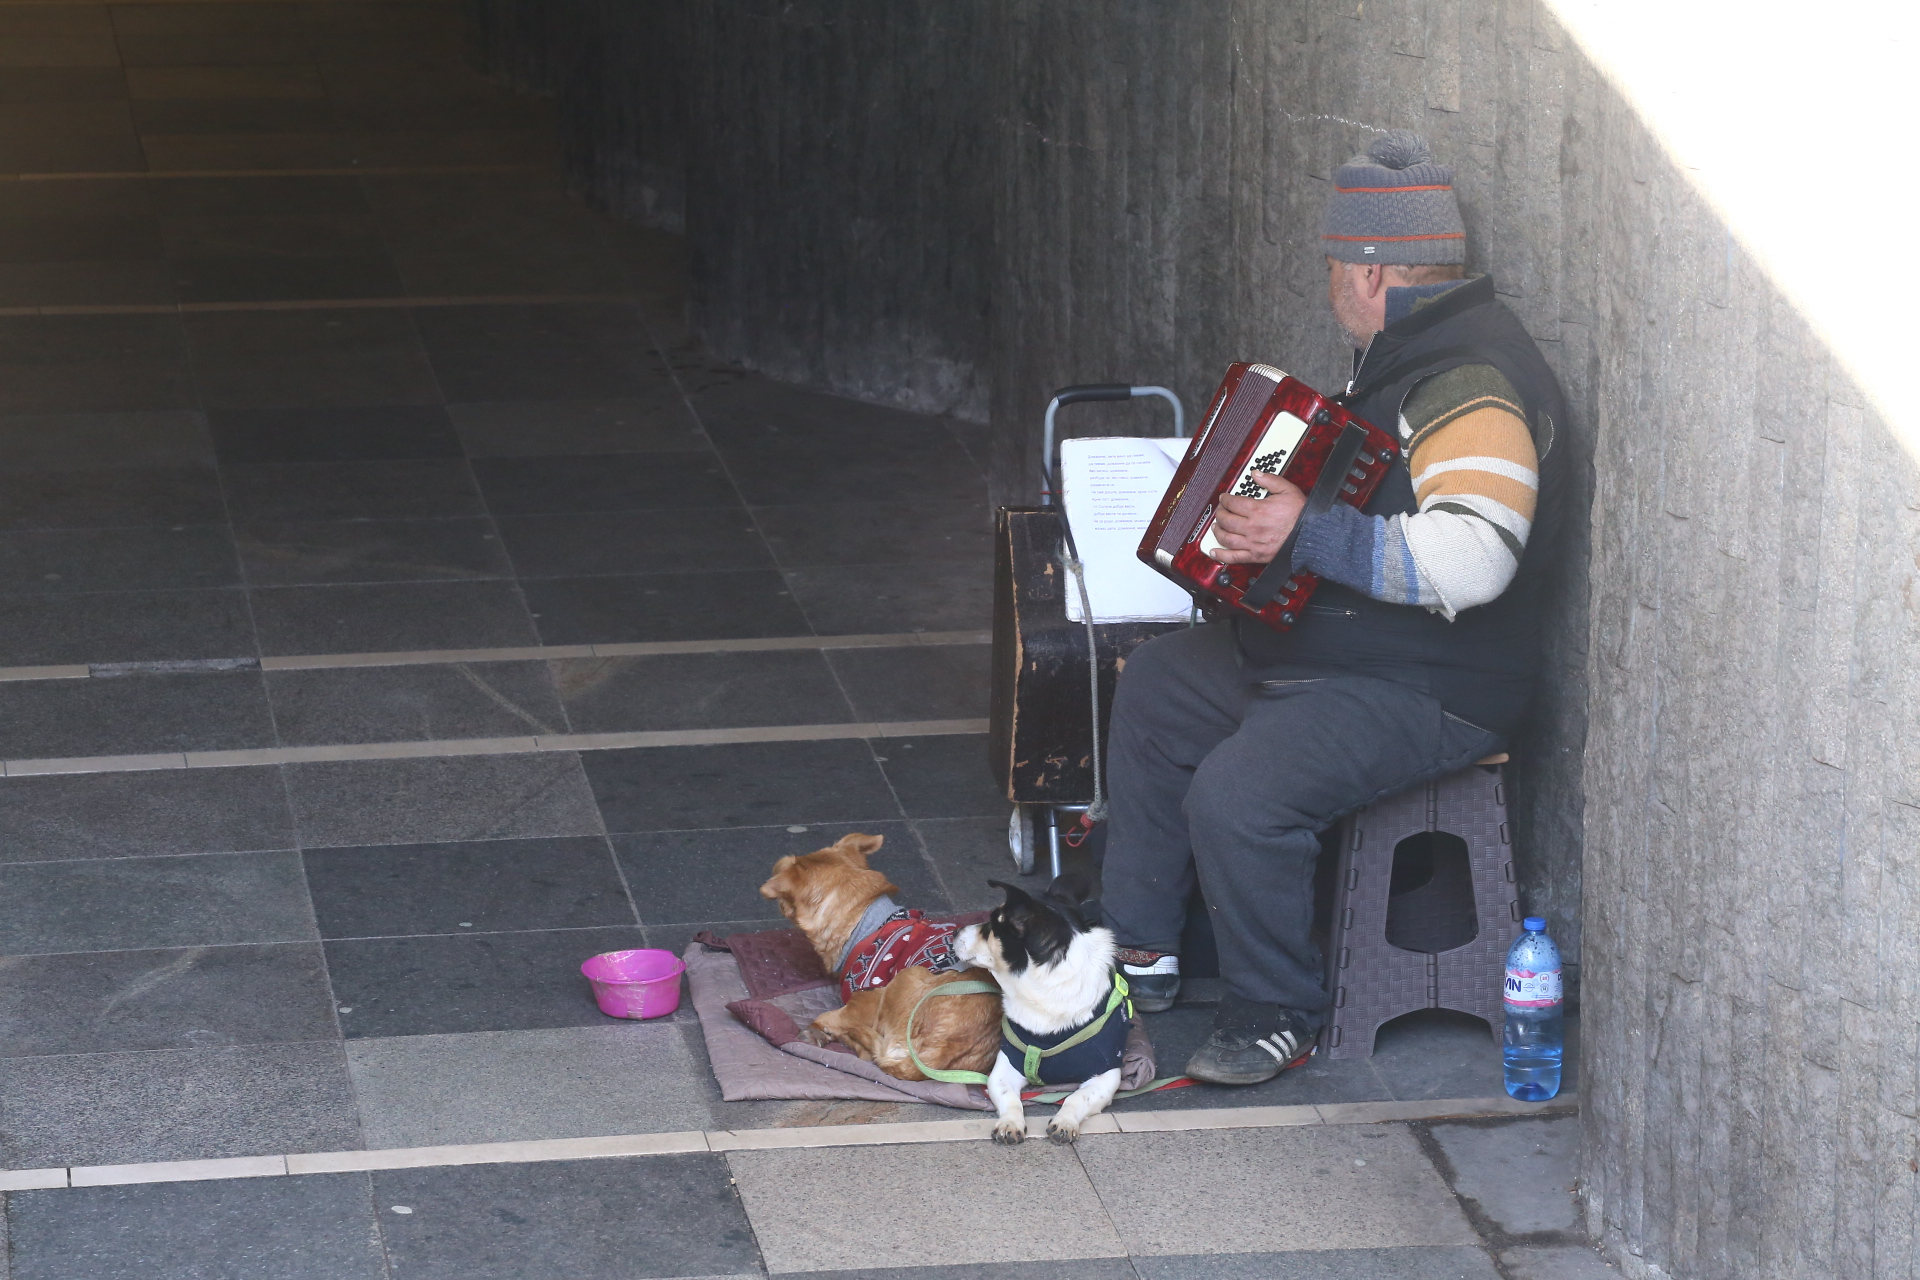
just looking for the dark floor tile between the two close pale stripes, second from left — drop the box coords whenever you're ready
[267,662,566,747]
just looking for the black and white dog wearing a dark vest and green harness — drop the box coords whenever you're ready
[952,877,1133,1146]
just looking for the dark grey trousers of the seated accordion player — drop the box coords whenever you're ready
[1100,624,1503,1021]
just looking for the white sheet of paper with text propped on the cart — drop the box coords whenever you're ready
[1060,436,1192,622]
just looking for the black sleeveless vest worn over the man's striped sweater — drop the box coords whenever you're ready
[1236,276,1572,733]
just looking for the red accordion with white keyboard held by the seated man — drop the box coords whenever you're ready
[1140,365,1400,631]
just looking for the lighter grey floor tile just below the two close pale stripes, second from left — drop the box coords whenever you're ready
[286,752,603,848]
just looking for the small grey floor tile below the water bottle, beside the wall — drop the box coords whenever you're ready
[1432,1117,1580,1236]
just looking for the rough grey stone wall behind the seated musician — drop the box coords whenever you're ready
[476,0,1920,1280]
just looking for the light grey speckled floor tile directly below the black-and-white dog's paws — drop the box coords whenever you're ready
[728,1140,1125,1274]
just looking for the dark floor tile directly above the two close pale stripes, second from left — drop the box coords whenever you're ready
[252,581,540,654]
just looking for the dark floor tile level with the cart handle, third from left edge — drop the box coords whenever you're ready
[447,402,710,459]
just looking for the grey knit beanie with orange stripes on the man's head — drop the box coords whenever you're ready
[1321,129,1467,267]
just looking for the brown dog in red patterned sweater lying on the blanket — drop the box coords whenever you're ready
[760,835,1000,1080]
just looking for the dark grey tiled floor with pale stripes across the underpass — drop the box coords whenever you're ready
[0,0,1605,1280]
